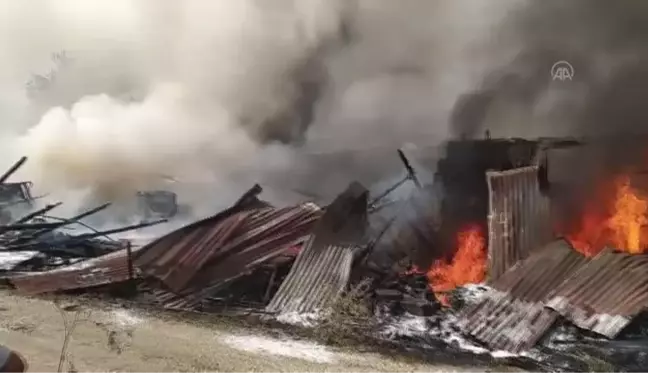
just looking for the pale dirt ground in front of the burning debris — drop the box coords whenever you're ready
[0,292,528,373]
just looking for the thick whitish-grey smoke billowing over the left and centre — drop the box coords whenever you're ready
[0,0,522,218]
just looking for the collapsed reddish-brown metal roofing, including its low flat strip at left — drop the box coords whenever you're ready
[9,186,322,309]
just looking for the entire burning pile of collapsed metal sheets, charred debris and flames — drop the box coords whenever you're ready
[0,139,648,371]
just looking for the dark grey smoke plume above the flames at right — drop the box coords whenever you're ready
[451,0,648,232]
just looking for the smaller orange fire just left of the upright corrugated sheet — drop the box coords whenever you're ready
[427,225,486,305]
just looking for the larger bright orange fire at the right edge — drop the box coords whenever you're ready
[567,175,648,256]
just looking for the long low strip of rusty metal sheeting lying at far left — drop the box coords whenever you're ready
[9,249,135,295]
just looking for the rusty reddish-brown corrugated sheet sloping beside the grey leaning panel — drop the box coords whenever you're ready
[135,204,321,296]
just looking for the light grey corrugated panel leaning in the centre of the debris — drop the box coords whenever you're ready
[266,241,354,313]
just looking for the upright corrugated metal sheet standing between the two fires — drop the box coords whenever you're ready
[486,166,552,281]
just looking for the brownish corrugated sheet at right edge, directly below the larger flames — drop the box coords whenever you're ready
[546,250,648,338]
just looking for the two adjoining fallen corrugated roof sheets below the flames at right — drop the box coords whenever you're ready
[459,240,648,352]
